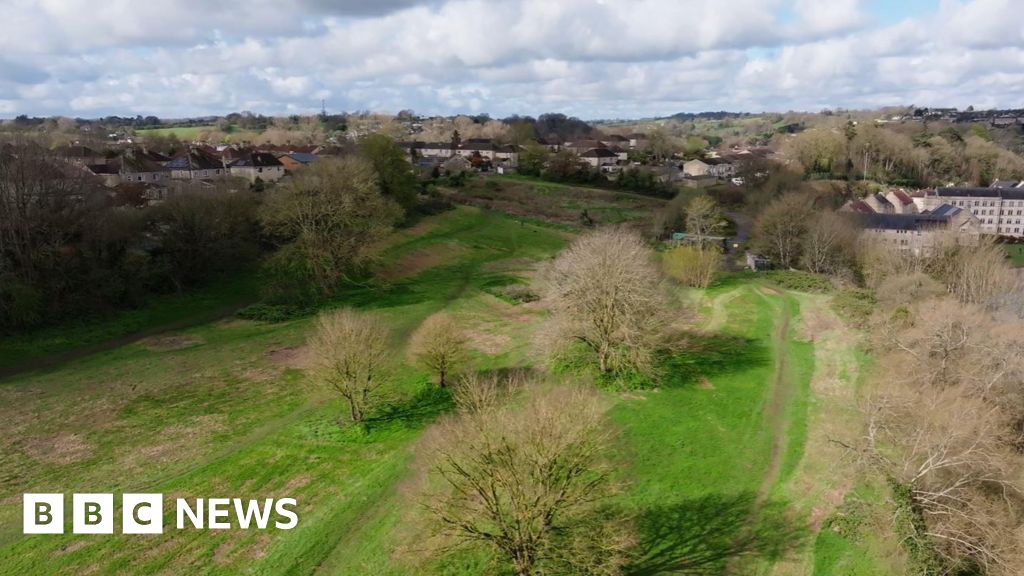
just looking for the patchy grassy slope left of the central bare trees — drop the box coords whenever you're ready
[0,209,564,574]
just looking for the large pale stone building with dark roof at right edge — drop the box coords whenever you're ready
[921,181,1024,238]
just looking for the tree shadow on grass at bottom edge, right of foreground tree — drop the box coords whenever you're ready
[627,493,807,576]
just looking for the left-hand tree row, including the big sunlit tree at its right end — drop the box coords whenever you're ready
[0,135,419,331]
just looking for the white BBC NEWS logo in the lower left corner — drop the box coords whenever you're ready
[22,494,299,534]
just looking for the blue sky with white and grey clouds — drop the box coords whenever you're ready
[0,0,1024,119]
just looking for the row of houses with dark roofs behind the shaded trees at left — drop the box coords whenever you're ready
[61,146,317,188]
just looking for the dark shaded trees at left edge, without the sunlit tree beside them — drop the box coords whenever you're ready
[0,145,259,331]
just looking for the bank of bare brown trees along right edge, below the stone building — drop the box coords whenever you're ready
[855,238,1024,576]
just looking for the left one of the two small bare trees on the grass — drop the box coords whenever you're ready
[309,308,391,422]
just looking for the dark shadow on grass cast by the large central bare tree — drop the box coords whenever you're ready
[663,332,771,387]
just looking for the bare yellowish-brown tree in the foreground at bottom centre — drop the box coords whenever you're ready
[422,381,632,576]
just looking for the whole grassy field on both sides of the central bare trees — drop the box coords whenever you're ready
[0,203,886,576]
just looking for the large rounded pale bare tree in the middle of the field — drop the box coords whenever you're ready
[543,229,667,374]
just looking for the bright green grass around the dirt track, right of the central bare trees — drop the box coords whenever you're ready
[613,286,813,574]
